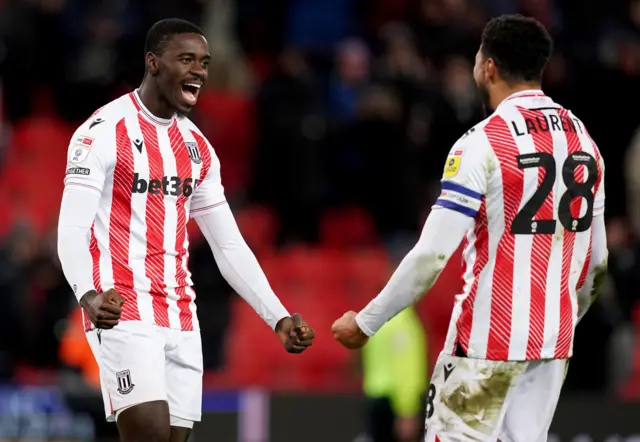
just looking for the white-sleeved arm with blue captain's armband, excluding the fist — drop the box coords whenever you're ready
[348,135,490,336]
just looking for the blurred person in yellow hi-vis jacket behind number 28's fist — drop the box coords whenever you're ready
[362,308,428,442]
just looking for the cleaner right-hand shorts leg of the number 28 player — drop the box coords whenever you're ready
[500,359,569,442]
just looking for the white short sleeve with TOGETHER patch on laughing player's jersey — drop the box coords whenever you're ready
[64,125,115,194]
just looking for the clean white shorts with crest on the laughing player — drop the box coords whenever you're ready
[86,321,202,422]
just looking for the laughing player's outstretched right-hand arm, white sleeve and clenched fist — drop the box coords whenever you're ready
[191,140,314,353]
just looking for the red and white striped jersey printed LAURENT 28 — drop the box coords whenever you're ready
[434,91,605,361]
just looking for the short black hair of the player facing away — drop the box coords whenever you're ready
[482,14,553,82]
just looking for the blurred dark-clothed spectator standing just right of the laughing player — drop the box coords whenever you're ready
[251,48,326,244]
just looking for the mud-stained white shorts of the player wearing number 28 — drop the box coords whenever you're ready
[425,354,569,442]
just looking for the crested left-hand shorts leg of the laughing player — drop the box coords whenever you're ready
[87,321,167,421]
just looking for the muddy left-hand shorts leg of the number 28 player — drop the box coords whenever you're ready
[425,354,526,442]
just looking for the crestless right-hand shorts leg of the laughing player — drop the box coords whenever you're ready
[166,330,202,427]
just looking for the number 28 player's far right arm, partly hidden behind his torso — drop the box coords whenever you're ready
[578,159,609,321]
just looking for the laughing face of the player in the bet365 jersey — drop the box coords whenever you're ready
[157,34,211,113]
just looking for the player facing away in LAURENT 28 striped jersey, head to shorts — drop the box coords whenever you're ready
[332,15,607,442]
